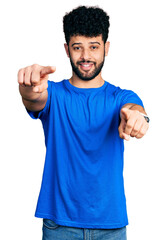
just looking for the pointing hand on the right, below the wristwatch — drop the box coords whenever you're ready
[118,107,149,141]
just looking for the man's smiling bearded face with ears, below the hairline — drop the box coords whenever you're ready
[65,35,109,81]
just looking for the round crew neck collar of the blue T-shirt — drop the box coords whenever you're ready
[64,79,108,93]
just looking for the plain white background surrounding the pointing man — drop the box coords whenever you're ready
[0,0,167,240]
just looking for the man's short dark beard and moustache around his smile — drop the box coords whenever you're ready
[70,52,105,81]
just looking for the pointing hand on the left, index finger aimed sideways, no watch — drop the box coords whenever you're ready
[18,64,56,93]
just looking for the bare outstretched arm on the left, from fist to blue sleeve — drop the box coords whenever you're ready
[18,64,55,111]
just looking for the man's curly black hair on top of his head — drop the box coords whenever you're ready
[63,6,110,44]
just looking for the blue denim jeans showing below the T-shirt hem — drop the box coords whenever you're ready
[42,219,127,240]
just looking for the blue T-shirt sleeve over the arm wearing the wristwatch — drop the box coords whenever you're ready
[119,89,144,111]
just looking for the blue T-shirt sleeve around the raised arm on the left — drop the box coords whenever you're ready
[26,81,52,120]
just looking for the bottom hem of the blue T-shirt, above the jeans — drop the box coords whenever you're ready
[35,212,129,229]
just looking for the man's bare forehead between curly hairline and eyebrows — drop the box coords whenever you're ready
[69,35,103,46]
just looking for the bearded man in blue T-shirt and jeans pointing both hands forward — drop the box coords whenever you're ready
[18,6,149,240]
